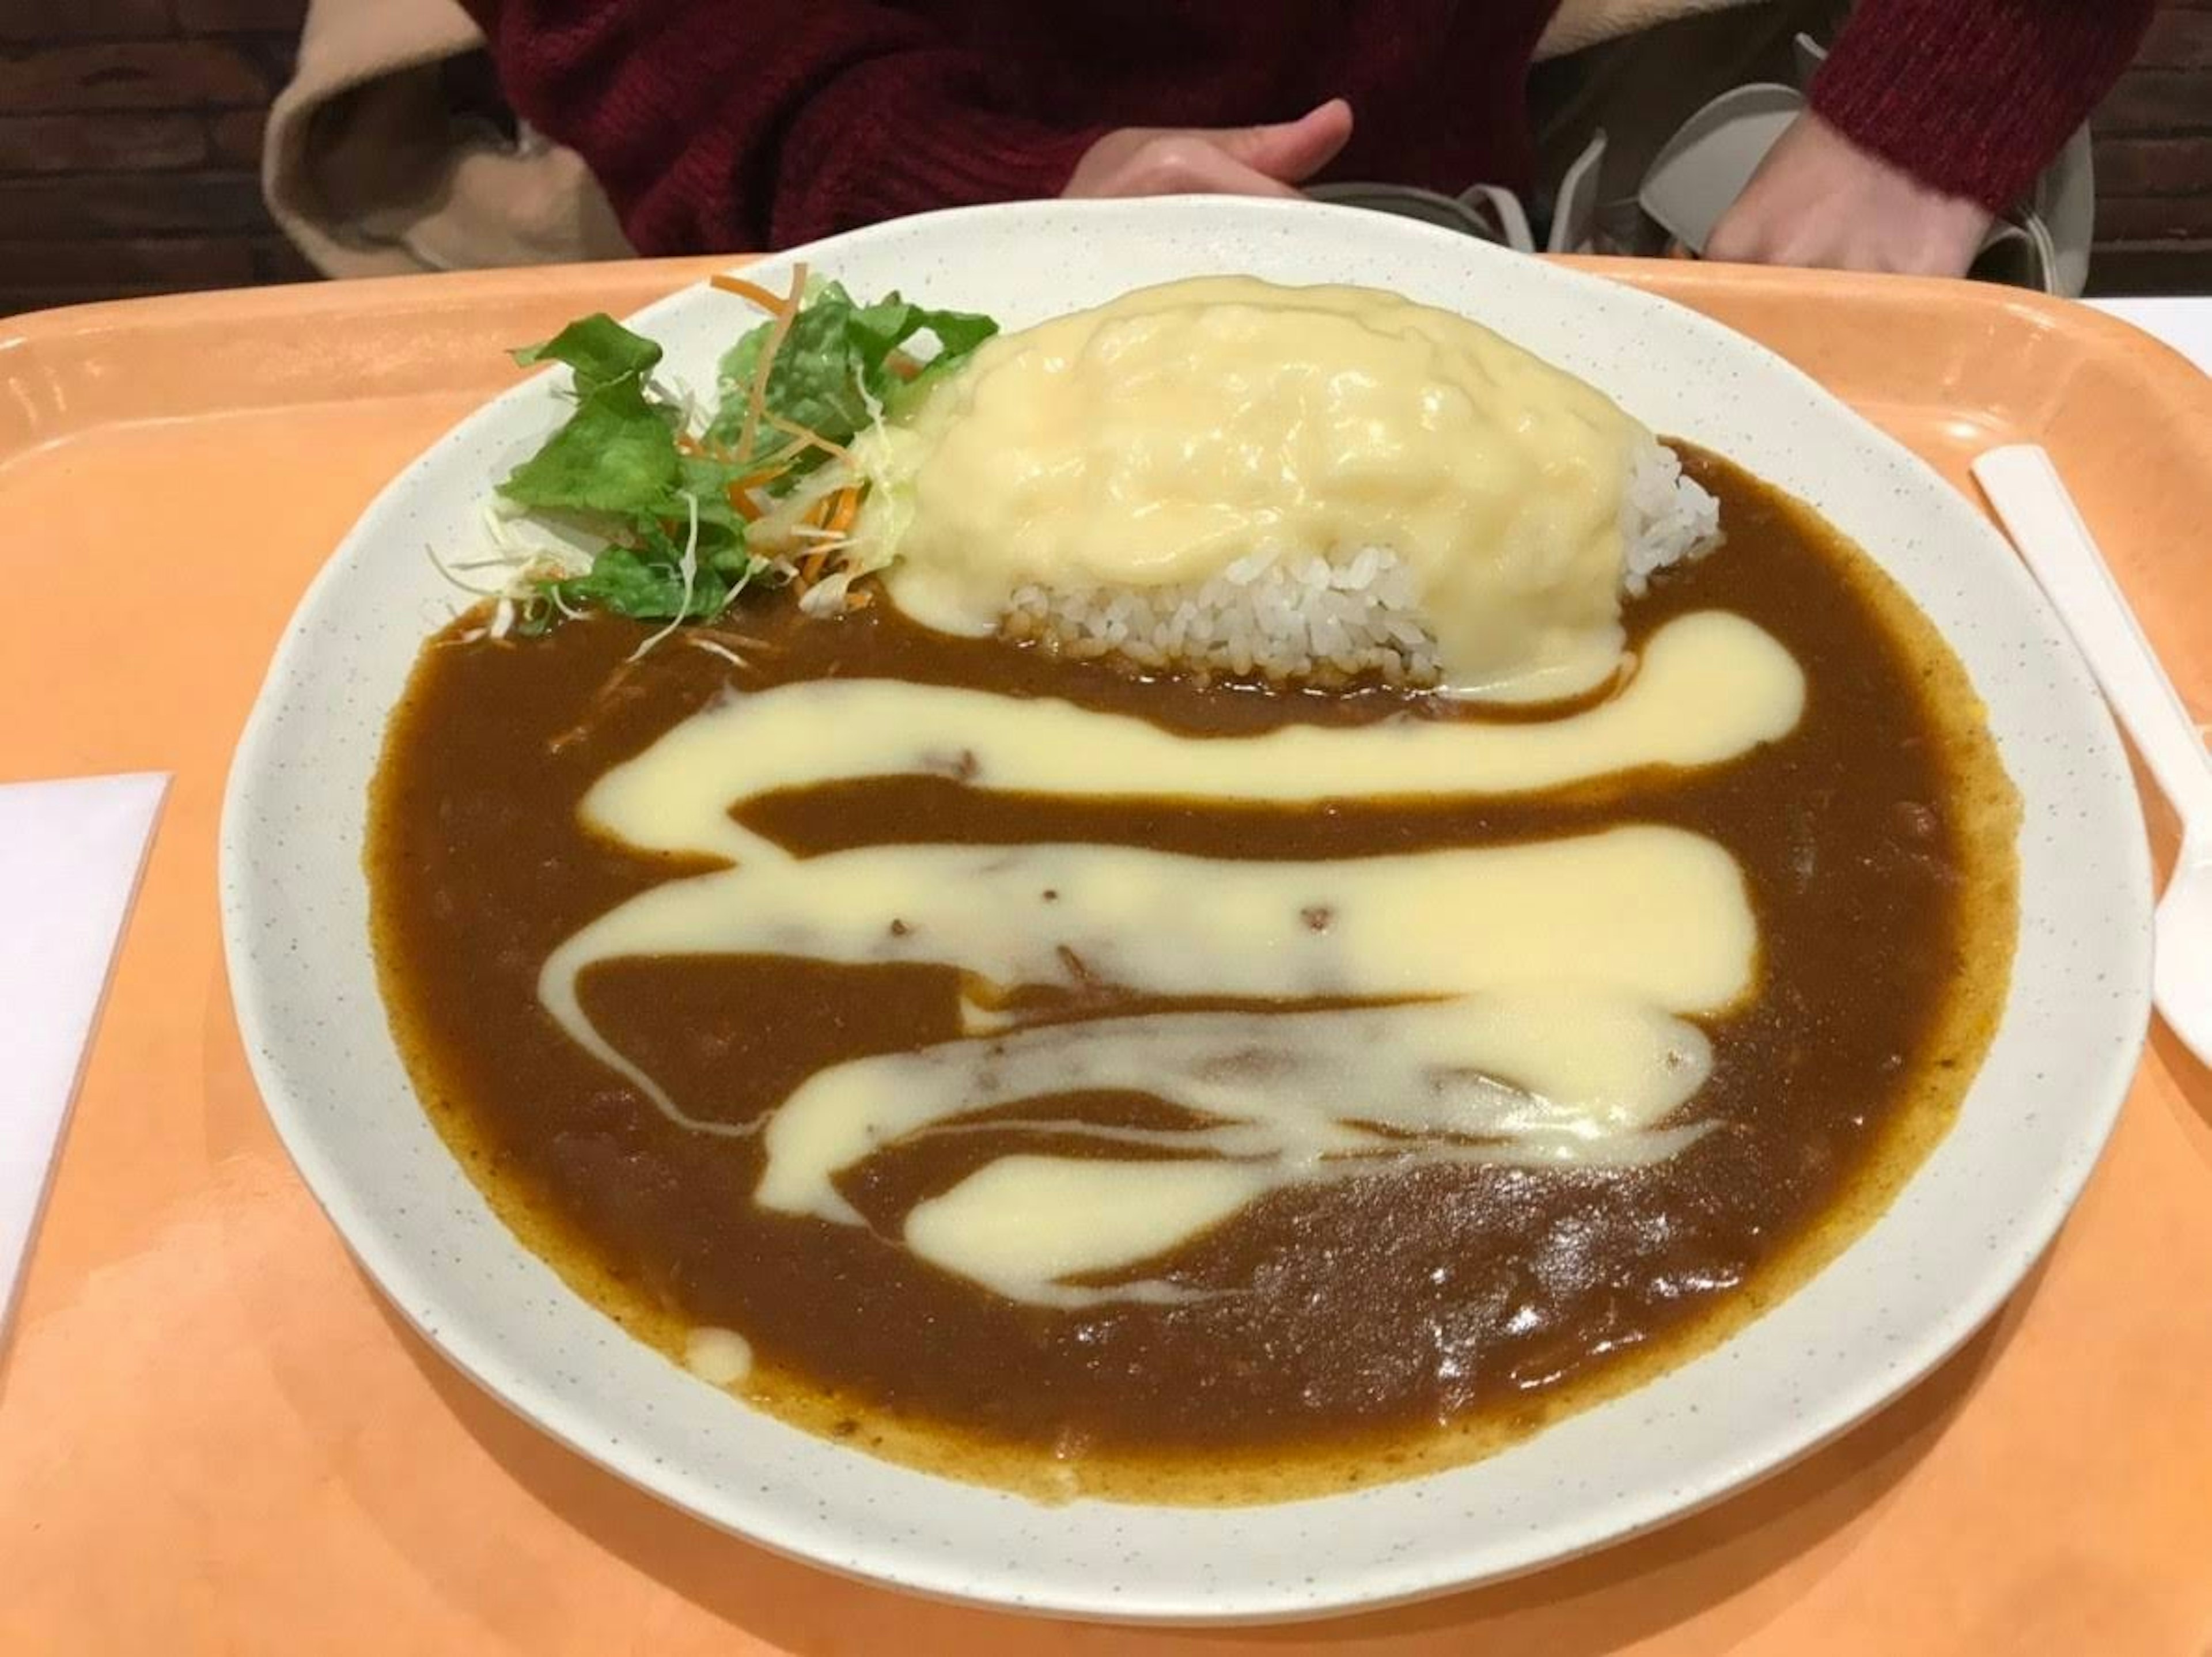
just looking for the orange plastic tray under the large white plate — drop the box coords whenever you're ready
[0,261,2212,1657]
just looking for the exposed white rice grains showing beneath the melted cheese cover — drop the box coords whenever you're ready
[1002,438,1721,688]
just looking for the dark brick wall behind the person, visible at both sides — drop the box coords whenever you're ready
[0,0,2212,314]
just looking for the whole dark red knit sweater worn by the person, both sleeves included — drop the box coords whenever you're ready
[467,0,2152,252]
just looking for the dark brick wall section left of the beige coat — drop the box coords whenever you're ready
[0,0,314,314]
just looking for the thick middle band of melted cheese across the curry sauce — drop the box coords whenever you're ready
[553,825,1759,1115]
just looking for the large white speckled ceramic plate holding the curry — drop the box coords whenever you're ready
[221,199,2150,1620]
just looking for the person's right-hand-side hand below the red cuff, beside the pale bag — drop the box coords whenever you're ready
[1706,111,1991,276]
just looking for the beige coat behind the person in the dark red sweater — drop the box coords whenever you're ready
[261,0,1749,276]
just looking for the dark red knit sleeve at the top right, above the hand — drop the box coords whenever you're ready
[1812,0,2154,213]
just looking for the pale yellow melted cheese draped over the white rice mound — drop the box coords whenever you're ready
[858,276,1650,697]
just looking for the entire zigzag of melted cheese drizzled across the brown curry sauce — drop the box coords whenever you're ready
[540,615,1803,1305]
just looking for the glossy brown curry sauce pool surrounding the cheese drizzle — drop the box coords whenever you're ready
[369,456,2015,1500]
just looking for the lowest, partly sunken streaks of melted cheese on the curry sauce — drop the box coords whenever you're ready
[756,989,1712,1305]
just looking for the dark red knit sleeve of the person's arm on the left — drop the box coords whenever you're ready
[469,0,1101,255]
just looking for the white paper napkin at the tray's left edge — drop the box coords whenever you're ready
[0,772,168,1332]
